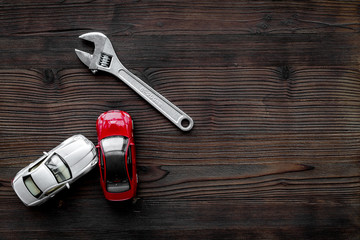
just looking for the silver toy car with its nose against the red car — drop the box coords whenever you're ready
[12,135,98,206]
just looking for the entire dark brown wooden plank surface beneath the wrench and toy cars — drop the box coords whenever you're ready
[0,0,360,240]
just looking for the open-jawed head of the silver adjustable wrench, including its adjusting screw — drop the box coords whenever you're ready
[75,32,117,74]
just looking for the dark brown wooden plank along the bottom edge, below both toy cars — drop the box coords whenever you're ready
[1,198,358,239]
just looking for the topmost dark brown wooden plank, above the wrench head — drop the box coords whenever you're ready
[0,1,360,37]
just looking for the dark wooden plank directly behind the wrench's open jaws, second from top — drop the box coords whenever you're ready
[0,31,360,68]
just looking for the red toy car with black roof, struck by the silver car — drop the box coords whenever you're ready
[96,110,138,201]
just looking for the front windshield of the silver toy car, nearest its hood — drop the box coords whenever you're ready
[45,154,71,183]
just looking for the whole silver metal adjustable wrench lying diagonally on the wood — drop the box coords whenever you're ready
[75,32,194,131]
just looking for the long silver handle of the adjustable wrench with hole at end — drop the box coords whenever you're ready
[115,68,194,131]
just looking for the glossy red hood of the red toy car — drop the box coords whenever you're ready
[96,110,132,141]
